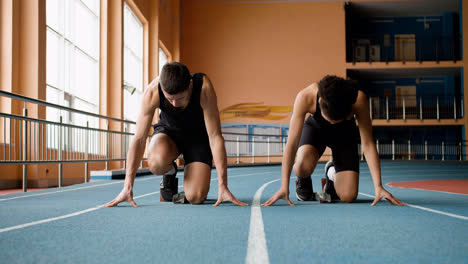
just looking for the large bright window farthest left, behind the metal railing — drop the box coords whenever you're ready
[46,0,100,152]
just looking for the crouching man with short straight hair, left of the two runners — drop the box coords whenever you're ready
[104,62,247,207]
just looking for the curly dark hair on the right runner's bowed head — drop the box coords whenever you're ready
[318,75,358,121]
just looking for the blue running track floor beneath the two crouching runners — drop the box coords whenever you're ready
[0,161,468,264]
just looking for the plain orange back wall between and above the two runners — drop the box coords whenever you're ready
[181,0,346,123]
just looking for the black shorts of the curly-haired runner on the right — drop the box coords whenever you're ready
[299,116,359,173]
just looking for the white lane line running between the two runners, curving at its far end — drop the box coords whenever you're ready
[245,179,281,264]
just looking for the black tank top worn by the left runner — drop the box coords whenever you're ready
[154,73,208,136]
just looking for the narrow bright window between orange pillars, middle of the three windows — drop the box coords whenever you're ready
[123,3,143,121]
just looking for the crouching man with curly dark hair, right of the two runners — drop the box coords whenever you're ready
[263,75,404,206]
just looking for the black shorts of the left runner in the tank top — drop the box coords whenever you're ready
[153,124,213,167]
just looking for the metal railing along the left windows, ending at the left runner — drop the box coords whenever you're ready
[0,91,141,191]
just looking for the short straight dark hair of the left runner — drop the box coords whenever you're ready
[159,62,192,94]
